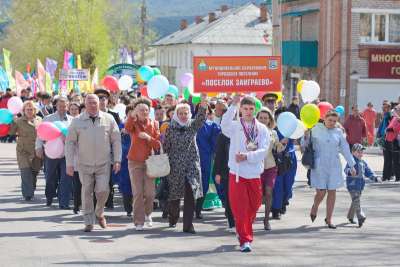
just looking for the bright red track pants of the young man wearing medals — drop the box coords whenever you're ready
[229,173,262,245]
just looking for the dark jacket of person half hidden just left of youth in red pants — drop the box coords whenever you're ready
[214,133,231,182]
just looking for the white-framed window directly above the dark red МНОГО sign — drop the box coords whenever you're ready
[360,13,400,43]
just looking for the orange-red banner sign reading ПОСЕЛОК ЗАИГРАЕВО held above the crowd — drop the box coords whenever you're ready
[193,56,282,93]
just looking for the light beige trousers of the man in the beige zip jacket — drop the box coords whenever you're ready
[79,164,111,225]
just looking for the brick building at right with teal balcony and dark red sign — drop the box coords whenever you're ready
[281,0,400,109]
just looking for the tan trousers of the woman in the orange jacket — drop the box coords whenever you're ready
[128,160,155,225]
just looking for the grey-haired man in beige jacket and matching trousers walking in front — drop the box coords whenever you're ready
[65,94,121,232]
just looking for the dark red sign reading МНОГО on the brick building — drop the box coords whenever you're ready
[368,49,400,79]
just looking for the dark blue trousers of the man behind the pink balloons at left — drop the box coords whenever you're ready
[45,157,72,207]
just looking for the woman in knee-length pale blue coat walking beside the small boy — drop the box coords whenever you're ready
[307,111,356,229]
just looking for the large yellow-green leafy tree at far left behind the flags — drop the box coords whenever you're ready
[0,0,112,73]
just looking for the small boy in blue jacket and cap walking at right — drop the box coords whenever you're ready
[345,143,378,227]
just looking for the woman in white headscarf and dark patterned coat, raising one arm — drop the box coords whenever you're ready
[164,100,207,234]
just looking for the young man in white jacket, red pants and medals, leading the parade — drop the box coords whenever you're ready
[221,95,269,252]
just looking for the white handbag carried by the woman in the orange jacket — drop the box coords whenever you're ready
[146,144,171,179]
